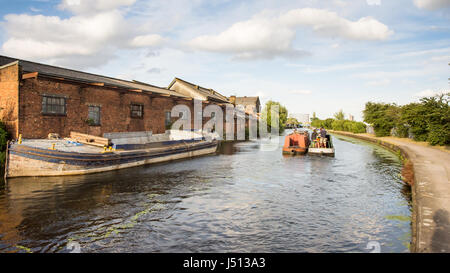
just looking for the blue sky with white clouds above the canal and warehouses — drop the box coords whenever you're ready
[0,0,450,120]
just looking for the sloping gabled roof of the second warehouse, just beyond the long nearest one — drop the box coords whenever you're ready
[168,78,230,103]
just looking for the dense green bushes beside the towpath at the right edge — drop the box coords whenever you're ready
[364,93,450,145]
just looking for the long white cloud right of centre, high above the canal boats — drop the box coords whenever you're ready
[188,8,393,59]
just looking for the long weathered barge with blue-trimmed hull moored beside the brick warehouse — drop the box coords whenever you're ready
[5,130,218,178]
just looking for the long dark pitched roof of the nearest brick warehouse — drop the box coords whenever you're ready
[0,55,187,98]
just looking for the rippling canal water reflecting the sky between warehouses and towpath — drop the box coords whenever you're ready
[0,133,411,252]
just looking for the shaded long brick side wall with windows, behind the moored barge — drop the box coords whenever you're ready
[19,78,199,138]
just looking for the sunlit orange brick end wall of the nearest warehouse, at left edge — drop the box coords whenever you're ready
[0,64,19,138]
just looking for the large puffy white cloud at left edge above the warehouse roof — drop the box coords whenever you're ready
[3,11,126,58]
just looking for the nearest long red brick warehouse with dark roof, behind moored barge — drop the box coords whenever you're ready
[0,56,228,138]
